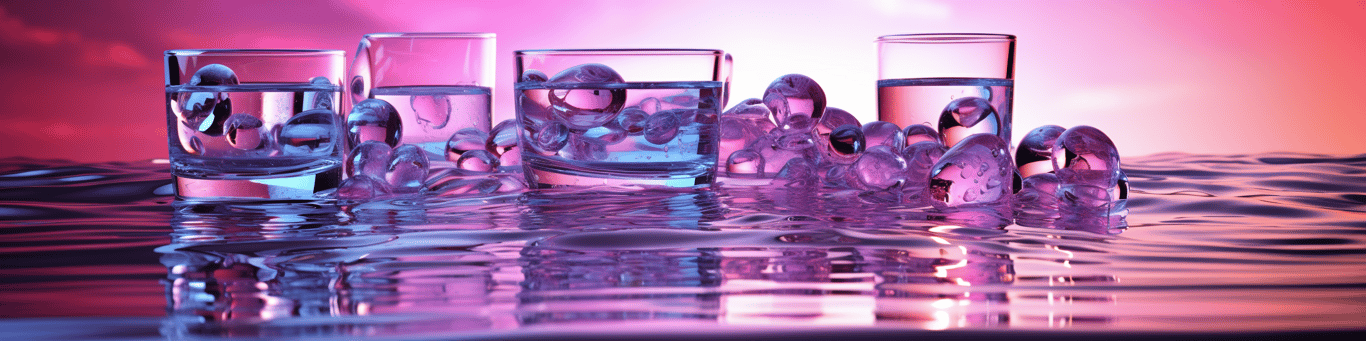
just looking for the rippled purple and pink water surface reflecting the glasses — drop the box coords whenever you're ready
[0,154,1366,337]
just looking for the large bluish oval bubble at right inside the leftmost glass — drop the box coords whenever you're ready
[279,109,342,157]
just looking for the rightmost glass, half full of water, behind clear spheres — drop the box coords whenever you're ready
[877,33,1015,147]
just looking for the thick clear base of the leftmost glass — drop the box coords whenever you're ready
[172,166,342,201]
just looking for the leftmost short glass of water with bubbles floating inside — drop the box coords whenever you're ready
[165,49,346,201]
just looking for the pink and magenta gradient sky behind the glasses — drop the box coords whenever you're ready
[0,0,1366,162]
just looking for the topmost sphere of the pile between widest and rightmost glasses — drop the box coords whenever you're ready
[764,74,825,130]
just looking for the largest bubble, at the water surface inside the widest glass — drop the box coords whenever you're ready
[546,64,626,131]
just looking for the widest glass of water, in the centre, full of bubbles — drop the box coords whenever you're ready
[515,49,728,188]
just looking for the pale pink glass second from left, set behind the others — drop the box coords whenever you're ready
[347,33,494,164]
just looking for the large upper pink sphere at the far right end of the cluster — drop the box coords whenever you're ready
[1053,125,1119,188]
